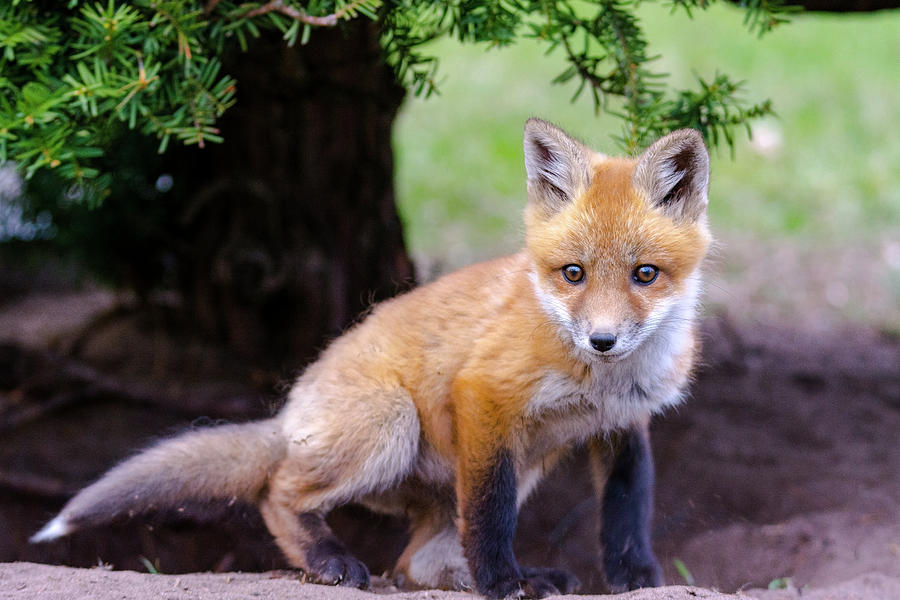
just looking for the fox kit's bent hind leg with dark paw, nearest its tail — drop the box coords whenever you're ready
[260,388,420,587]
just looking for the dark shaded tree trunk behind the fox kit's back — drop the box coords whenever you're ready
[171,19,413,368]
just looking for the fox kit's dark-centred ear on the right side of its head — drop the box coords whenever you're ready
[633,129,709,222]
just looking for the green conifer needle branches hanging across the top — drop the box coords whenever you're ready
[0,0,781,197]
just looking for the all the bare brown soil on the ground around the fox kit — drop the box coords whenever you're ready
[0,292,900,600]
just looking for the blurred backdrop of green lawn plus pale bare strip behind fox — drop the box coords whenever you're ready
[394,5,900,331]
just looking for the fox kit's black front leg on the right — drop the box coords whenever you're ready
[591,427,662,593]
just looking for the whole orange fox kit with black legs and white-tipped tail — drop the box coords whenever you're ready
[31,118,711,598]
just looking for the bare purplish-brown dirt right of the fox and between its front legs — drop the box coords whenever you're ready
[519,319,900,591]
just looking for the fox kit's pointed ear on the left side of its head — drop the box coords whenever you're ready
[525,119,594,216]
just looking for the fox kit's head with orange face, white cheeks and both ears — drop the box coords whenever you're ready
[525,119,710,362]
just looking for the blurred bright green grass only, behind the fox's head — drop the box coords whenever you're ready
[395,4,900,276]
